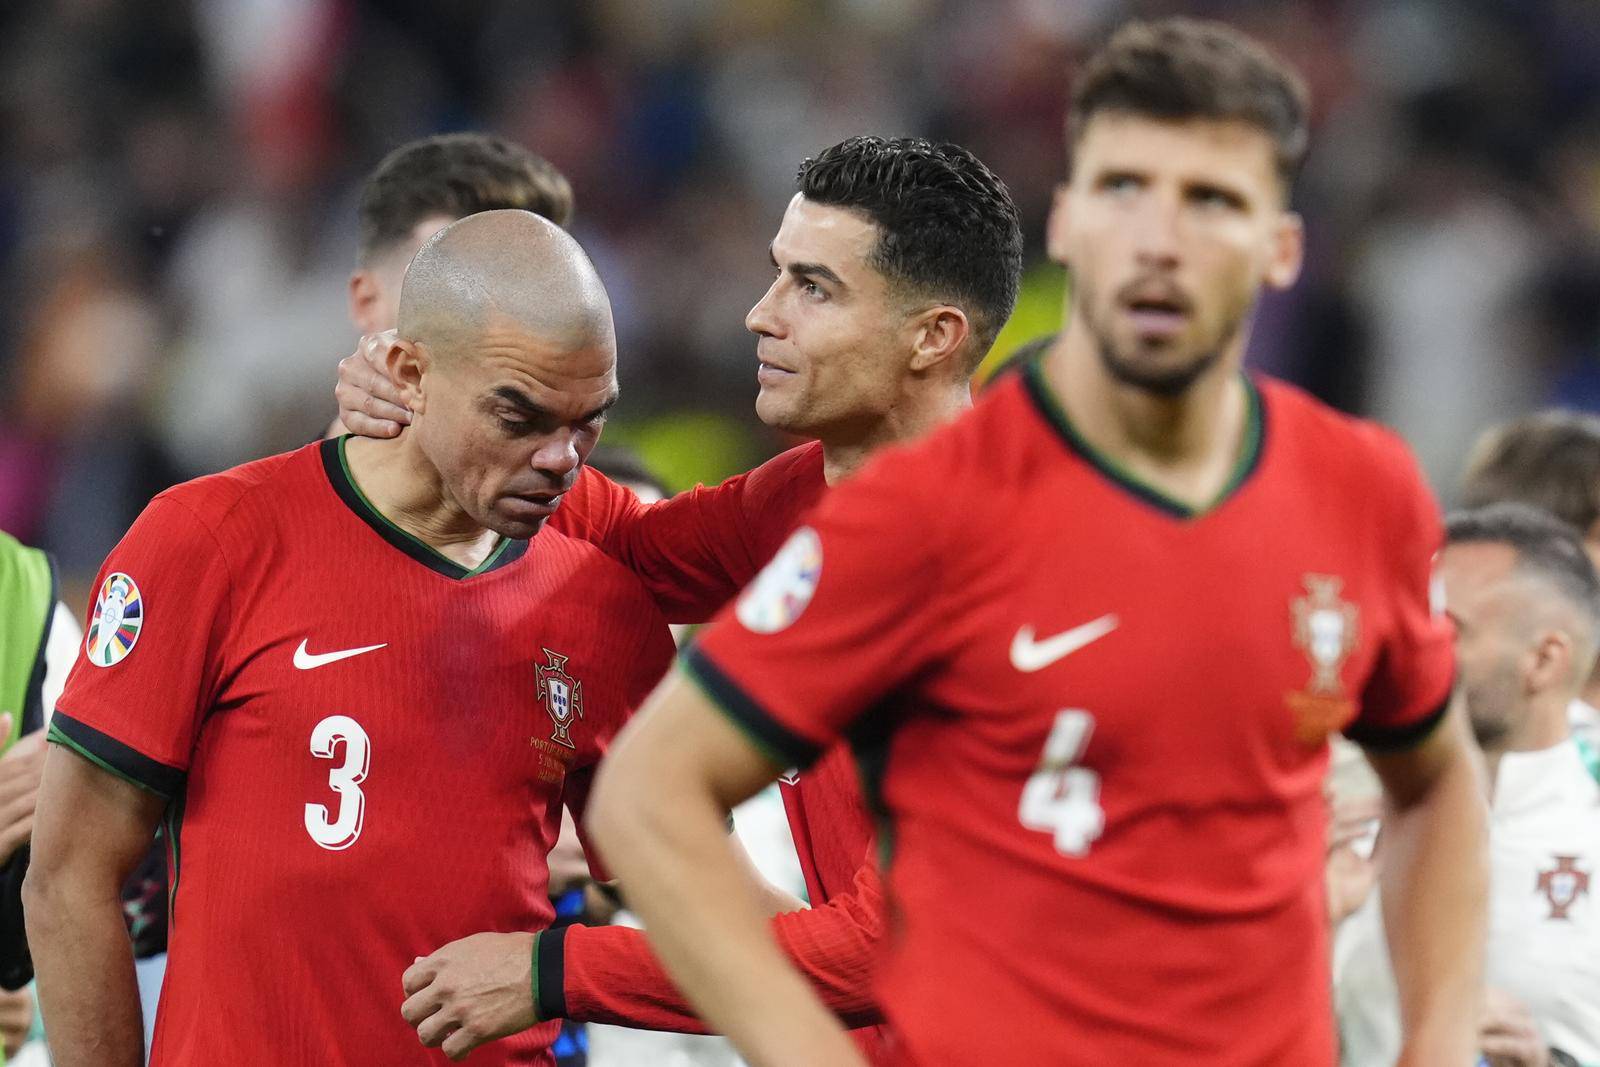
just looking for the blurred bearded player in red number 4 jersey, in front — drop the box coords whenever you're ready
[590,19,1485,1067]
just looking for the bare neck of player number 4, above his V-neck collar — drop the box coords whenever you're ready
[1045,317,1251,507]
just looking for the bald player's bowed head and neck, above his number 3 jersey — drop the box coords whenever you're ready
[347,211,618,566]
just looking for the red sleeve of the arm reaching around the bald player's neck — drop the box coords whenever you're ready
[552,450,822,622]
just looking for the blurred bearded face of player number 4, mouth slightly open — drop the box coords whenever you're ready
[1050,112,1301,395]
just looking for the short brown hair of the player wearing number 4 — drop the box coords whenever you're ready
[1067,18,1310,190]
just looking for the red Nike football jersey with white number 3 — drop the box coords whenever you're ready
[53,442,672,1067]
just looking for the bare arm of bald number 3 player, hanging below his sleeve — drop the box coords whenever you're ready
[22,745,166,1067]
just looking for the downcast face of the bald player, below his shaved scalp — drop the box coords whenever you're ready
[413,313,616,539]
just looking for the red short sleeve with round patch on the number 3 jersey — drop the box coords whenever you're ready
[50,496,232,797]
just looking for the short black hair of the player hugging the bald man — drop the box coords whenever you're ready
[795,138,1022,370]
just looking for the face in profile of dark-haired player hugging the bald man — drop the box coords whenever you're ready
[744,194,906,437]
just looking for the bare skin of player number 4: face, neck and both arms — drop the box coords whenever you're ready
[589,114,1486,1067]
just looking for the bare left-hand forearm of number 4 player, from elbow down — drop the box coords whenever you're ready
[594,780,861,1067]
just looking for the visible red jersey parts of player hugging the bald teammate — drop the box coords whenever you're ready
[542,442,886,1062]
